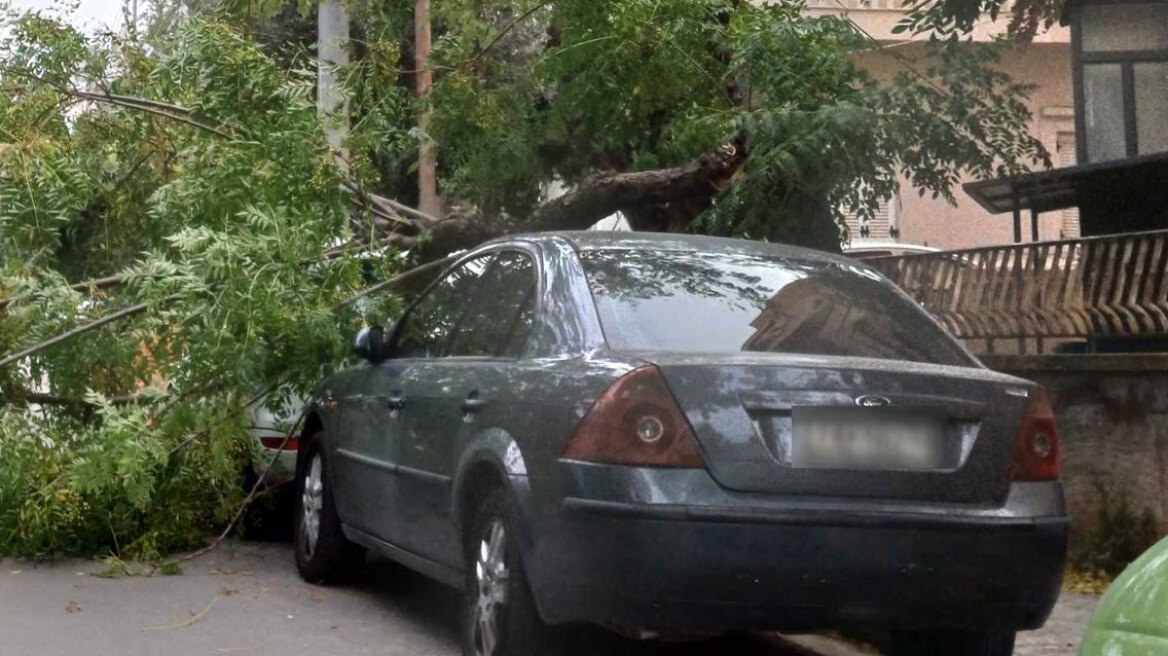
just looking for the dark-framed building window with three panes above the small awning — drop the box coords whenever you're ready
[1073,0,1168,162]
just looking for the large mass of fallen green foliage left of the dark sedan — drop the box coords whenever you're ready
[0,6,401,557]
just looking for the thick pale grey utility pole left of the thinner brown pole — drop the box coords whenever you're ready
[317,0,349,166]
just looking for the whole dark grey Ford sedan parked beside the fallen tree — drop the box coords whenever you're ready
[297,232,1068,656]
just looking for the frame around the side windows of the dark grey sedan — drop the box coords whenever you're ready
[387,243,544,362]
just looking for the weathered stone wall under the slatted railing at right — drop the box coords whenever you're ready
[982,354,1168,535]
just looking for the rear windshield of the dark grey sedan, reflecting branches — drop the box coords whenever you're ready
[580,250,973,367]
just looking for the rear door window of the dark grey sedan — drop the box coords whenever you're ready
[449,251,536,357]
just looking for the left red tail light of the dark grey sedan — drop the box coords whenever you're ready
[561,365,703,467]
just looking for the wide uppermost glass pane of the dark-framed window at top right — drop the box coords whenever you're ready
[1080,2,1168,53]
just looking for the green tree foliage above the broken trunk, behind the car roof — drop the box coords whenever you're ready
[418,0,1049,243]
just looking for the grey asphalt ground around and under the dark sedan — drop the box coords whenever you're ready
[0,543,1092,656]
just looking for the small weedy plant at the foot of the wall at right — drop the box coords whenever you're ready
[1069,486,1159,579]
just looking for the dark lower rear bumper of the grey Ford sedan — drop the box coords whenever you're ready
[528,464,1069,634]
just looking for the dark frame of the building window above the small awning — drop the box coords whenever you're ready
[1068,0,1168,165]
